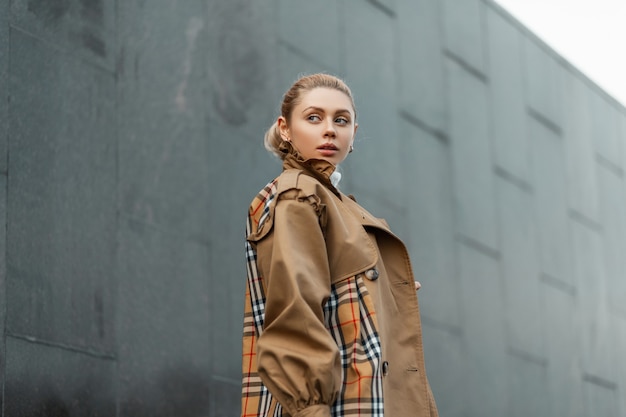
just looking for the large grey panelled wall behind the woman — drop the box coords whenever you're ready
[0,0,626,417]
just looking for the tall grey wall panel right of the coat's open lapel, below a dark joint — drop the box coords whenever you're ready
[400,120,460,327]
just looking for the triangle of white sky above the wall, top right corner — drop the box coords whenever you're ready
[495,0,626,106]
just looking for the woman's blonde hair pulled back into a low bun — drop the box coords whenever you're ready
[264,73,356,159]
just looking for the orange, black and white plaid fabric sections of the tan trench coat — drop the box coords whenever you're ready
[241,180,384,417]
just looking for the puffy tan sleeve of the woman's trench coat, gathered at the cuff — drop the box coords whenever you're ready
[257,190,341,417]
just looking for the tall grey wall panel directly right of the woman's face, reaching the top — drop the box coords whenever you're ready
[343,3,404,218]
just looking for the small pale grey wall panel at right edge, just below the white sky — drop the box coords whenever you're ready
[589,92,626,170]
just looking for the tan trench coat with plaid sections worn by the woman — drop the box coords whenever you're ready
[242,146,437,417]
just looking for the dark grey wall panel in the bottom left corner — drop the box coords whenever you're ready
[4,337,116,417]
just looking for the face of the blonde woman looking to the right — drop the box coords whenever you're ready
[278,87,358,165]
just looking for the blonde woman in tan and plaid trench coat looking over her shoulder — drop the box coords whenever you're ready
[241,74,437,417]
